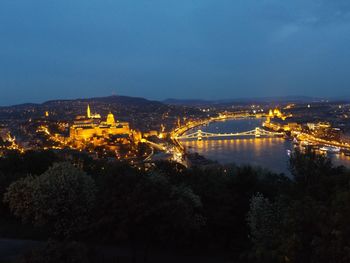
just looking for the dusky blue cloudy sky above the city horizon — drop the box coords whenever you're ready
[0,0,350,105]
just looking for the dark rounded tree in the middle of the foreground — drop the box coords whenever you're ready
[122,174,205,245]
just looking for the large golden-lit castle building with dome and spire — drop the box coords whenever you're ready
[69,105,130,141]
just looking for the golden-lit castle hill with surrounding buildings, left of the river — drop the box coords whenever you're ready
[0,105,153,159]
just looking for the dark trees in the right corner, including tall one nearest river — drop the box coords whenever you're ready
[247,151,350,262]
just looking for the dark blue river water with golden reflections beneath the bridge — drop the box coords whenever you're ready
[182,119,350,174]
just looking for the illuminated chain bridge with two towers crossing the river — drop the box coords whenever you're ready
[177,127,284,141]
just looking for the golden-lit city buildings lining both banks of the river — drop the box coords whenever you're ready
[0,102,350,163]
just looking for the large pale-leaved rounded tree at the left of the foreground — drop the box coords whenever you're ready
[4,163,95,237]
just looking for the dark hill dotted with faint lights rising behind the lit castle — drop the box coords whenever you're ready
[0,96,204,131]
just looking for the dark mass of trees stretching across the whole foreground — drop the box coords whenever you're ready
[0,151,350,263]
